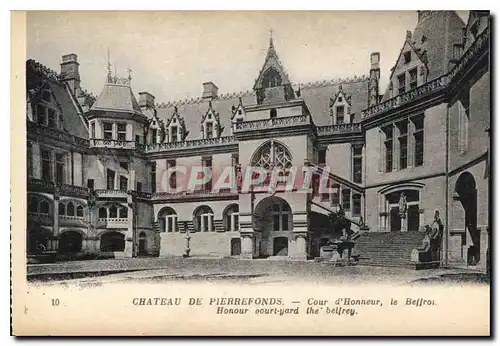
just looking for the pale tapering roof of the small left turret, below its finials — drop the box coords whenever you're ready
[91,83,143,115]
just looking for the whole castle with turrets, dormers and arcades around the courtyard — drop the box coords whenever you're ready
[26,11,490,267]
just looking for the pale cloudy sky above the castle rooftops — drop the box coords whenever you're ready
[26,11,468,103]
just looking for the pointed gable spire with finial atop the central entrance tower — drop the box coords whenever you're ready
[253,29,295,104]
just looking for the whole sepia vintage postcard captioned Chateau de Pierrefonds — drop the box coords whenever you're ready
[11,10,492,336]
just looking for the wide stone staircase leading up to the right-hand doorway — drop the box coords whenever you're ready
[352,231,425,267]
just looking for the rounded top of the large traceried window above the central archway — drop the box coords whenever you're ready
[252,140,292,170]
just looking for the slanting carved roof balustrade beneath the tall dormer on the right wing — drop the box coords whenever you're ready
[361,75,449,119]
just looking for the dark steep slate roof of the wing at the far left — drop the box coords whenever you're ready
[26,59,88,138]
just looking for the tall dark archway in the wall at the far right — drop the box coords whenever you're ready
[455,172,480,265]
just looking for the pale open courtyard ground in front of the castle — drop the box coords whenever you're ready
[27,258,489,285]
